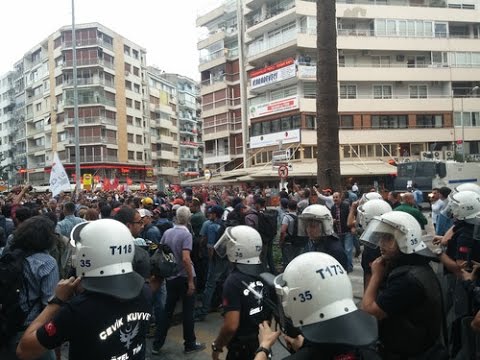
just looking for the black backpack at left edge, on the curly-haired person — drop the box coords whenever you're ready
[0,249,30,349]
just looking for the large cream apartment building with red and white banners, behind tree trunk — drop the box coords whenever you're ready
[197,0,480,181]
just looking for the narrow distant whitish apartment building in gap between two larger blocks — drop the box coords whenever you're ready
[158,73,203,180]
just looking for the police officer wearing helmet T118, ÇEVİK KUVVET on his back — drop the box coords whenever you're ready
[17,219,151,360]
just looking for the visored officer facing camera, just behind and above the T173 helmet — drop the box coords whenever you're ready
[298,204,348,269]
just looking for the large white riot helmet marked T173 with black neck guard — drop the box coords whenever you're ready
[274,252,377,346]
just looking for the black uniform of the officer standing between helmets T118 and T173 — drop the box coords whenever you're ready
[223,268,271,360]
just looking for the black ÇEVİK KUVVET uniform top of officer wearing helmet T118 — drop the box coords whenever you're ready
[37,288,152,360]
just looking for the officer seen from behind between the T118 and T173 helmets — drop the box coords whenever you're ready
[212,225,271,360]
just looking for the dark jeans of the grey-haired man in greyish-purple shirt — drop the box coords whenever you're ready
[153,276,197,348]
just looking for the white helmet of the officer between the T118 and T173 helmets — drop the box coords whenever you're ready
[214,225,264,275]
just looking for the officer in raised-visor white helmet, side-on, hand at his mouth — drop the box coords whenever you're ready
[360,211,446,360]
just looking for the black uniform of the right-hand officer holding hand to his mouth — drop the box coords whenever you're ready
[376,254,443,359]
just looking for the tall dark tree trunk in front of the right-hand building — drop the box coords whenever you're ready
[316,0,341,190]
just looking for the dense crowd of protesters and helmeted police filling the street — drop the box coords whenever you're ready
[0,184,480,360]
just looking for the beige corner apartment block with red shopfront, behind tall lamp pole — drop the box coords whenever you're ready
[0,23,189,184]
